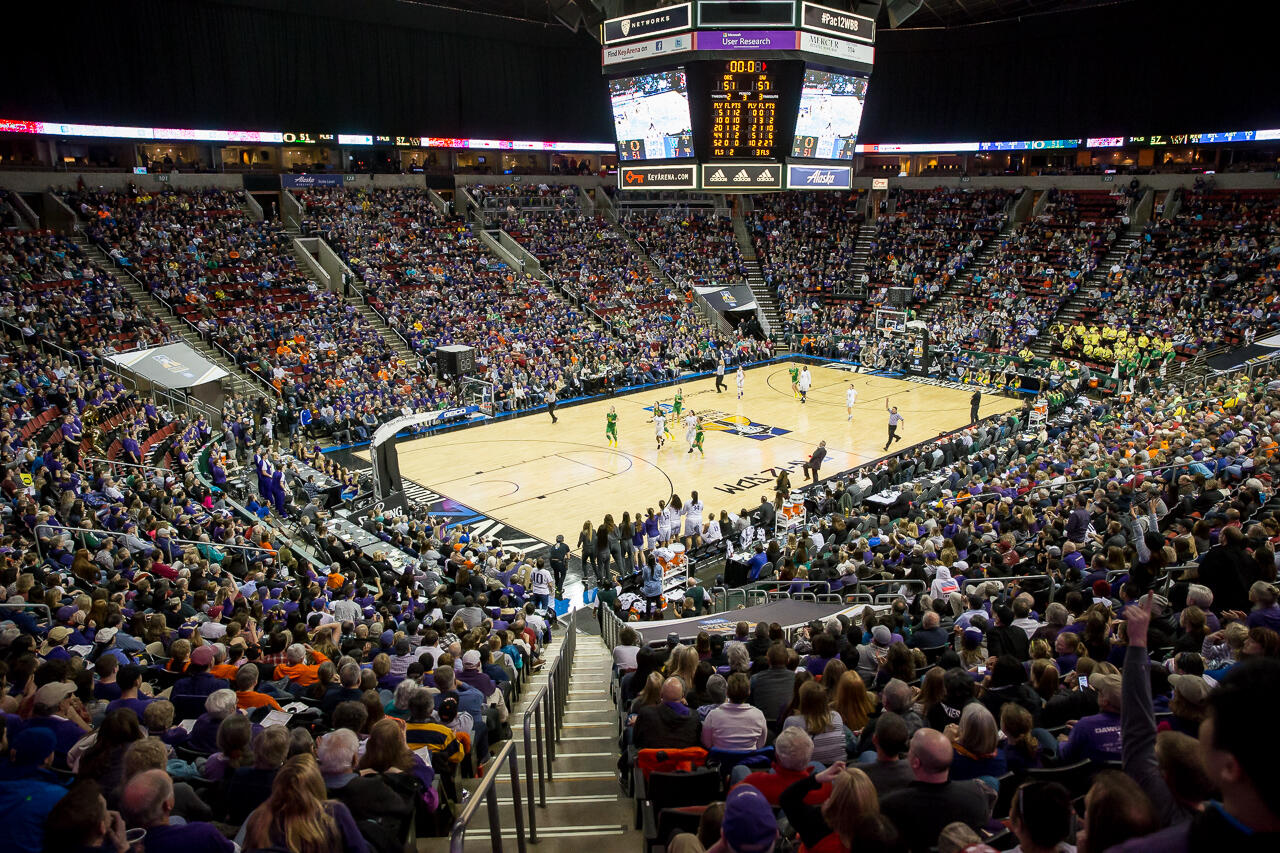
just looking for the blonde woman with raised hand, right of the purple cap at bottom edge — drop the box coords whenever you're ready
[778,761,882,853]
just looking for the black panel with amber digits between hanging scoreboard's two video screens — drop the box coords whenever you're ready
[708,59,782,159]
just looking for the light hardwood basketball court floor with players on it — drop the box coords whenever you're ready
[373,361,1020,546]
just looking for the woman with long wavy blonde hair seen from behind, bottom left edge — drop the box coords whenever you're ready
[241,754,369,853]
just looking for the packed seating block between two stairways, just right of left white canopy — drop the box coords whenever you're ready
[69,190,439,420]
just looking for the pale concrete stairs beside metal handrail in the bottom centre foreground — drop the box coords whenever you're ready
[417,620,643,853]
